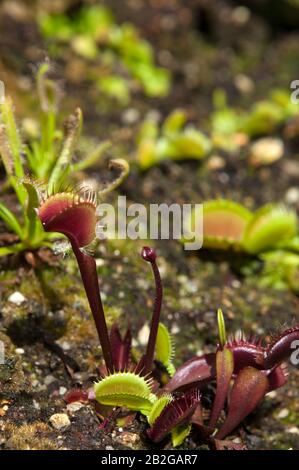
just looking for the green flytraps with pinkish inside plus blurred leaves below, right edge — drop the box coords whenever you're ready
[188,199,299,291]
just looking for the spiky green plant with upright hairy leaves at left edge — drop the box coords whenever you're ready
[0,64,124,256]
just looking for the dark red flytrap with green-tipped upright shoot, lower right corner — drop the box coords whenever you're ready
[164,311,299,447]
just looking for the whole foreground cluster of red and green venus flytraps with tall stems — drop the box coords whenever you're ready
[38,187,299,448]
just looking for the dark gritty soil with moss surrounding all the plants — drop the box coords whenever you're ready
[0,0,299,449]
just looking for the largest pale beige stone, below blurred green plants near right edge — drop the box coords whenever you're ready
[249,137,284,167]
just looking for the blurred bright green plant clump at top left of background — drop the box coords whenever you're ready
[38,5,170,105]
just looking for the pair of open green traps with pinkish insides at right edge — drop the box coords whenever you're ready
[192,199,299,255]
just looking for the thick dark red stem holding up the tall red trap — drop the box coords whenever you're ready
[71,242,114,373]
